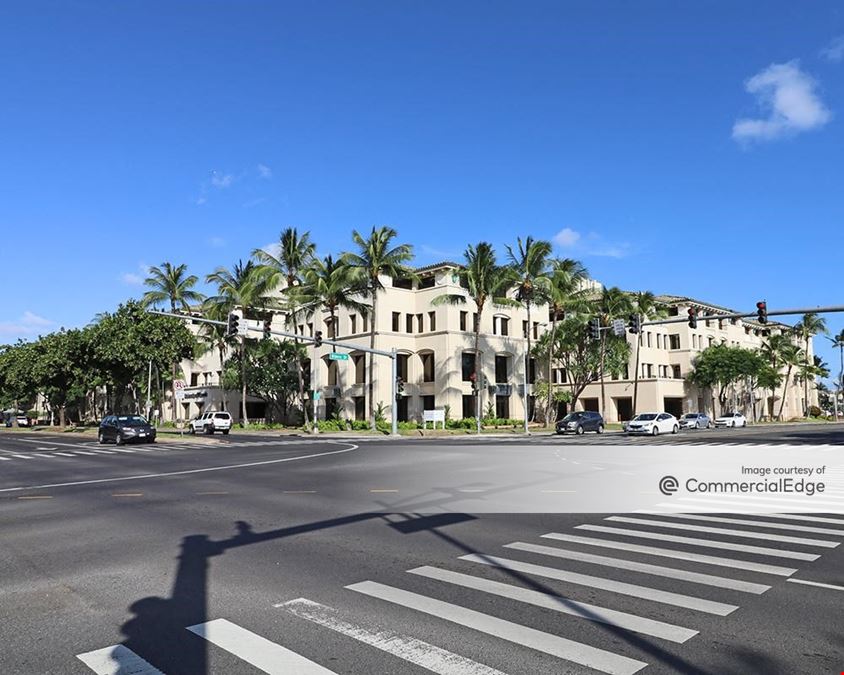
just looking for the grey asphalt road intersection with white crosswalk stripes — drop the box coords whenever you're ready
[0,425,844,675]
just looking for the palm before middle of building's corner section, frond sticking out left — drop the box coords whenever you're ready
[431,241,510,433]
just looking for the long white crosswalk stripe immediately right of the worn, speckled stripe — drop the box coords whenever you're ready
[346,581,648,675]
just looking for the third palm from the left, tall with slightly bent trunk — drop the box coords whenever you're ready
[252,227,316,427]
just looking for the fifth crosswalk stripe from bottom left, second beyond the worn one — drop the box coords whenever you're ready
[409,566,698,643]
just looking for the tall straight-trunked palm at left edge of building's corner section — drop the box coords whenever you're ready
[343,226,413,429]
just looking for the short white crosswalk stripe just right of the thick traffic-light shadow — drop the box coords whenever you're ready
[187,619,334,675]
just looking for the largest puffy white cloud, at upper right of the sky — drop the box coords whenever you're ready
[733,60,832,141]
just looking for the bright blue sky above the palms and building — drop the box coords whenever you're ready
[0,1,844,380]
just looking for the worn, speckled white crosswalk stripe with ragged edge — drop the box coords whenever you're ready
[275,598,505,675]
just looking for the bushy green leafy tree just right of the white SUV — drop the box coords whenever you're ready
[223,340,305,422]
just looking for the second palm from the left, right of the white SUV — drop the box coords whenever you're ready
[205,260,266,425]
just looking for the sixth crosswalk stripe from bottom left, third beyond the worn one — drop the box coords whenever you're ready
[460,553,738,616]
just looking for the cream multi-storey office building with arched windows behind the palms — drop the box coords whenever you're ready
[170,263,816,421]
